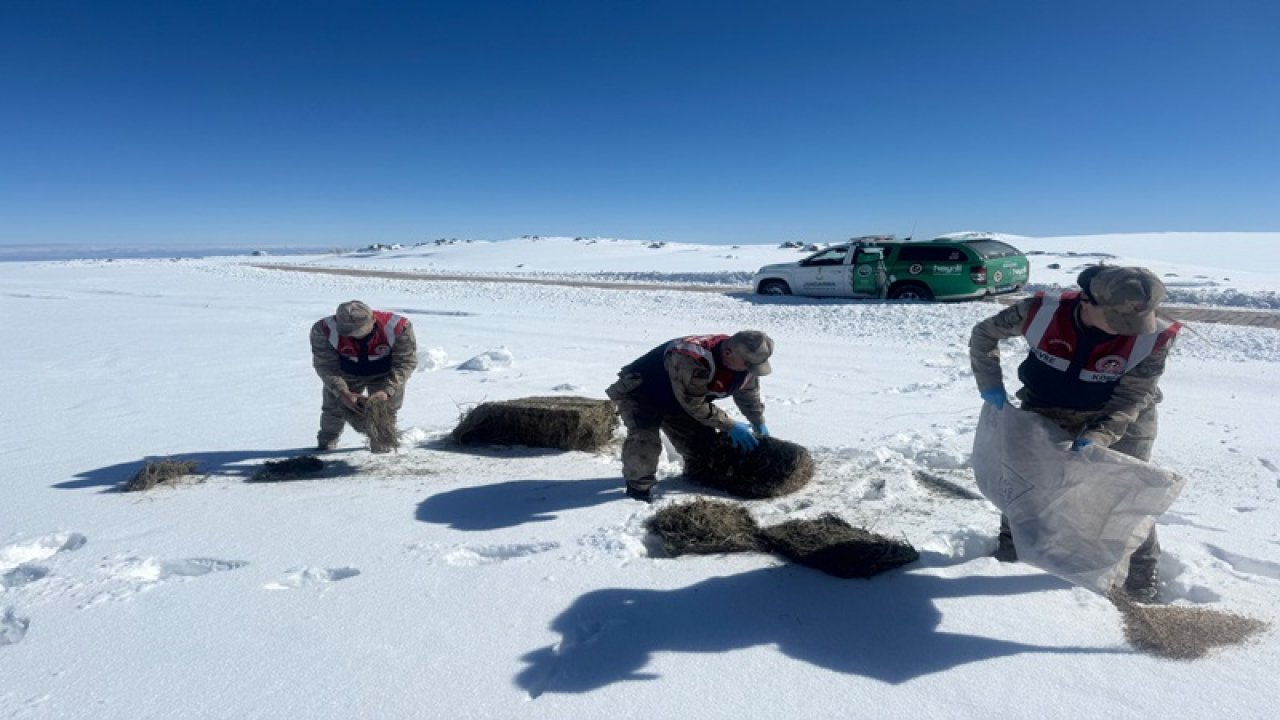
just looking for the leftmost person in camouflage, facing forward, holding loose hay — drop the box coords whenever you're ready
[311,300,417,451]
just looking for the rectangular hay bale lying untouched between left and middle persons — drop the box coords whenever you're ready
[453,396,618,451]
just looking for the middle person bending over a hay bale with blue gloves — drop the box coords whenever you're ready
[605,331,773,502]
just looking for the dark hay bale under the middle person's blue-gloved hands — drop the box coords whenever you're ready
[685,433,814,498]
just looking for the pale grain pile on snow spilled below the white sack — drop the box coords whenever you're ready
[1111,593,1267,660]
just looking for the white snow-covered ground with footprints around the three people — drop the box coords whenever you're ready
[0,233,1280,719]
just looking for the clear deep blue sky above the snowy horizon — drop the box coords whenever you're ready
[0,0,1280,246]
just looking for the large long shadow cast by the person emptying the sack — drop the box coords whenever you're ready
[516,566,1129,697]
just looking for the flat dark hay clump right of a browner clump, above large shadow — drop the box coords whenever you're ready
[760,514,920,578]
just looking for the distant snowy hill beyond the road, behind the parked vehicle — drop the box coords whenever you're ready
[249,232,1280,307]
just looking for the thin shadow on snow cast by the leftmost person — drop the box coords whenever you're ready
[52,447,357,492]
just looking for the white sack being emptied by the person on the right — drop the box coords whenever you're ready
[973,402,1187,594]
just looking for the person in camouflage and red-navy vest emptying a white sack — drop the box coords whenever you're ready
[969,265,1181,602]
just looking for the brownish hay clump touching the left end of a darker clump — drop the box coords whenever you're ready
[649,498,764,556]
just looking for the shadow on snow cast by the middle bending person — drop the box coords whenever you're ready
[416,478,622,530]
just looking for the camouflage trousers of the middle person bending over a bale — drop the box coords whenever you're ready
[605,375,716,489]
